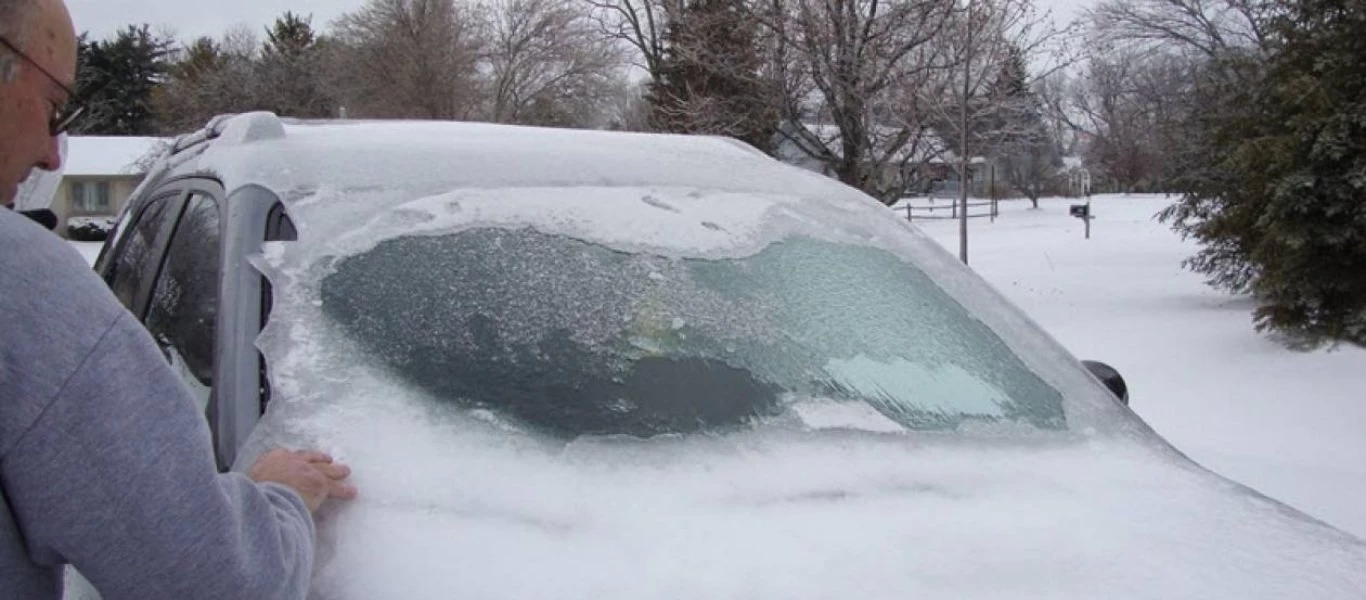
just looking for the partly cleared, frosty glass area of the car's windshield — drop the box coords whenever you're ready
[321,228,1065,437]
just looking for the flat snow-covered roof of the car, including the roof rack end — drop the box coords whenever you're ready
[157,112,870,206]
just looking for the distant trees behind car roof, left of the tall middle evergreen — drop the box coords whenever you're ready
[79,0,628,135]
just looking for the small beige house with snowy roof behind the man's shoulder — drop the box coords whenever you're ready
[49,135,167,235]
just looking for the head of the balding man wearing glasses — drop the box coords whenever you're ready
[0,0,76,205]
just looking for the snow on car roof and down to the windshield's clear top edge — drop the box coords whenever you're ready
[192,113,896,256]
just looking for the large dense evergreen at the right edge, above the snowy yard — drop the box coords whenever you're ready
[1161,0,1366,347]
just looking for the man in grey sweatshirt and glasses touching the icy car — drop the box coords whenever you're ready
[0,0,355,600]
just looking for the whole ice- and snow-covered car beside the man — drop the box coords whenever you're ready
[96,113,1366,600]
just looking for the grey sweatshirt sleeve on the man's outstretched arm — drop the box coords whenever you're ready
[0,314,314,600]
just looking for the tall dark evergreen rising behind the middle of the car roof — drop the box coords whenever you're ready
[646,0,779,152]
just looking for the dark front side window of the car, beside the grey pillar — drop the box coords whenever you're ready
[143,194,221,407]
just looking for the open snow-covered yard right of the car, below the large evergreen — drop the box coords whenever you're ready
[919,195,1366,537]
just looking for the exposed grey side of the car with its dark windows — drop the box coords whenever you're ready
[97,178,295,470]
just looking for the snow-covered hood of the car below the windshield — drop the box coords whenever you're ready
[240,399,1366,600]
